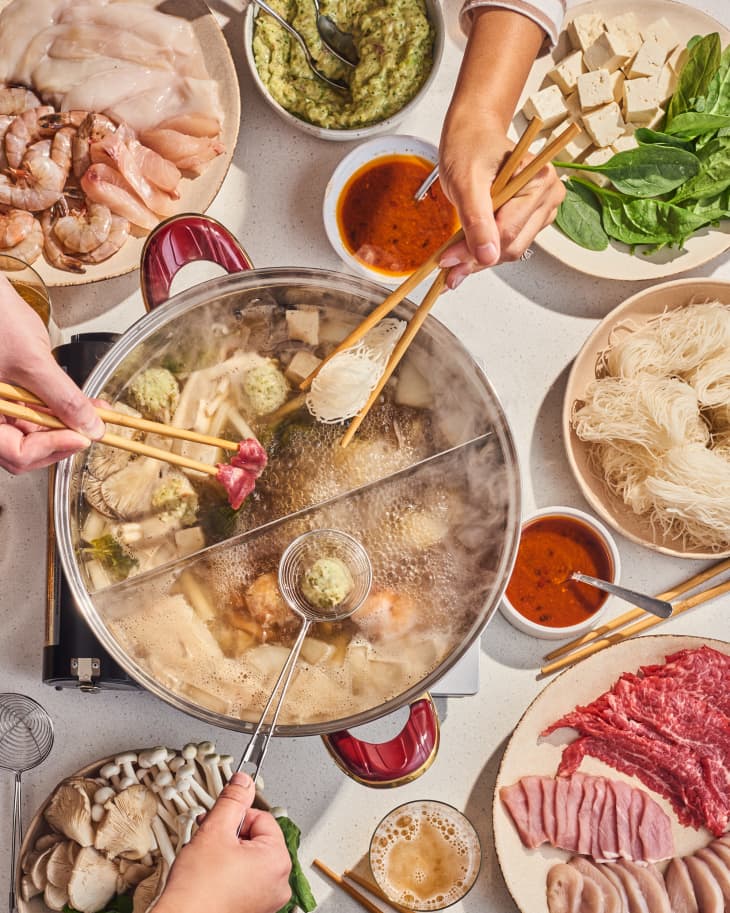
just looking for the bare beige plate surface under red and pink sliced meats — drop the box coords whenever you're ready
[493,635,730,913]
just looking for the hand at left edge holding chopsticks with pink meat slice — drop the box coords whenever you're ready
[0,275,104,473]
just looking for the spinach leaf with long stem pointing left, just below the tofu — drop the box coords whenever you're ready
[555,144,700,197]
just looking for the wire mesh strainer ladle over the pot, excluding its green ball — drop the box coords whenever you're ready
[236,529,373,780]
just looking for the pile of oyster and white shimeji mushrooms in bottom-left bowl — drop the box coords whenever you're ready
[21,742,233,913]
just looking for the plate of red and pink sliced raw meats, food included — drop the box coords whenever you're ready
[493,635,730,913]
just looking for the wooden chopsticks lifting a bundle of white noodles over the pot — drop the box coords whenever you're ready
[299,117,581,447]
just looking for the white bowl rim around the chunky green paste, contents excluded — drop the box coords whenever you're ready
[243,0,445,142]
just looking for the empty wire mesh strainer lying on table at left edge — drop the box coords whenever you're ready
[0,692,53,913]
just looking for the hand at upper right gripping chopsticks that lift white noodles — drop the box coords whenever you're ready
[439,105,565,289]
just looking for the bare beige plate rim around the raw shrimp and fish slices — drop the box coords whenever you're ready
[0,0,241,287]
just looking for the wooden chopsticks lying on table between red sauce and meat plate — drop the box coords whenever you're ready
[540,558,730,675]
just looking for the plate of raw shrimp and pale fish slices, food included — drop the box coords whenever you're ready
[0,0,241,287]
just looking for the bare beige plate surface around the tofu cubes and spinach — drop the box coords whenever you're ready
[515,0,730,281]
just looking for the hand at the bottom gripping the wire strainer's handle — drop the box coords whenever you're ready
[155,773,291,913]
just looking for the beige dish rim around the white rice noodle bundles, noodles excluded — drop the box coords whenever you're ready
[563,279,730,559]
